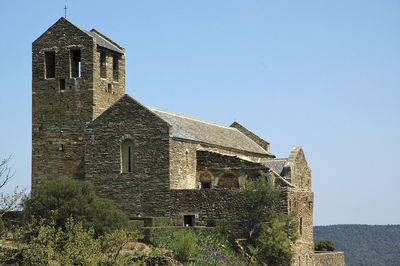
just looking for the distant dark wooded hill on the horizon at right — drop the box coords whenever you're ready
[314,224,400,266]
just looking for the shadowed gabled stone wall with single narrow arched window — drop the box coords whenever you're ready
[85,95,169,216]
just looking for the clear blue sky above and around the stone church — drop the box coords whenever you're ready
[0,0,400,225]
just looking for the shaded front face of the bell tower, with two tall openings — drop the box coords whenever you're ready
[32,18,95,185]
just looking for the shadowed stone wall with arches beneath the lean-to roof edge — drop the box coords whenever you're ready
[197,151,269,189]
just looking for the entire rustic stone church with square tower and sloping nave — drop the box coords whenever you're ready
[32,18,343,265]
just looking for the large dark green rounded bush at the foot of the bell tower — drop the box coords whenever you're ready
[24,178,128,235]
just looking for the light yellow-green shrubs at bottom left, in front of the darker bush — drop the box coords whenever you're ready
[15,217,138,265]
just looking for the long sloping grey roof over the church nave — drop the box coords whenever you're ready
[149,108,268,154]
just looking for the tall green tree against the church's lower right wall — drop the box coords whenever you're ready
[244,173,297,265]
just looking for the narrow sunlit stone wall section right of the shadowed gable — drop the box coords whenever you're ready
[169,139,199,189]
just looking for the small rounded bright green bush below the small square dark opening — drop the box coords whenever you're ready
[171,230,196,261]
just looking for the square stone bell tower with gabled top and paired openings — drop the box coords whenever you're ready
[32,18,125,186]
